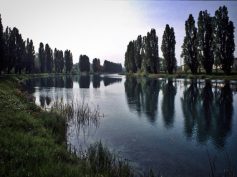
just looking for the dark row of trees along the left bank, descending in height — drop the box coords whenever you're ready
[0,15,73,74]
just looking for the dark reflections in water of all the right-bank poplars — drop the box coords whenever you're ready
[124,77,233,148]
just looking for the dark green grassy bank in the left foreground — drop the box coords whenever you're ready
[0,76,152,177]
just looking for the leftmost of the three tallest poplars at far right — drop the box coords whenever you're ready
[181,14,198,74]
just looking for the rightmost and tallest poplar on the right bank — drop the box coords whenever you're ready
[215,6,235,74]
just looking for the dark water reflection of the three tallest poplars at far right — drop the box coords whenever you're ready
[181,80,233,148]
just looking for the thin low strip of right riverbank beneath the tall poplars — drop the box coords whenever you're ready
[124,73,237,80]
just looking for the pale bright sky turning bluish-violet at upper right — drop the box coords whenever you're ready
[0,0,237,65]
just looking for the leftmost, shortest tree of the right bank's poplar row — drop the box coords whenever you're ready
[124,41,137,73]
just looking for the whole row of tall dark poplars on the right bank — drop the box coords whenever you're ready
[124,6,235,74]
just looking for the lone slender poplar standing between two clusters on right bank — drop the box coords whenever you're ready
[161,25,176,74]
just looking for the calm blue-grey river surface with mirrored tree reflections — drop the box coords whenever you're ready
[27,75,237,177]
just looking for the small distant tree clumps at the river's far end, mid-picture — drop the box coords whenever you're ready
[78,55,122,73]
